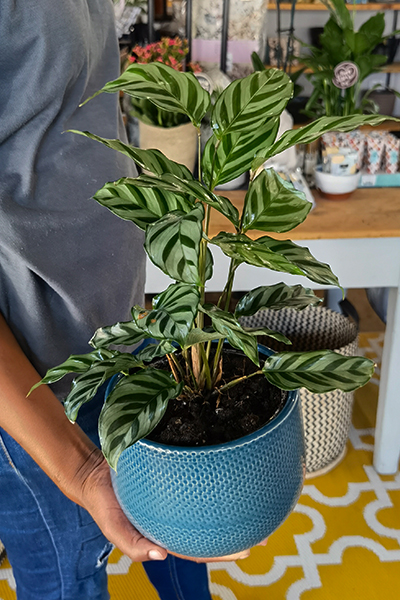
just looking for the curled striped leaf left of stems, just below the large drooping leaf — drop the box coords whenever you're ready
[132,283,200,346]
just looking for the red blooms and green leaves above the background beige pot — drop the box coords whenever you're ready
[128,37,201,127]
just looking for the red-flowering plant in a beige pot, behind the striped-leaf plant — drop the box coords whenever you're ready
[127,37,201,171]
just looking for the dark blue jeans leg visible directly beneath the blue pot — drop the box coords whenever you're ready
[143,554,211,600]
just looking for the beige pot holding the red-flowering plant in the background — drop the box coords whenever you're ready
[139,121,197,172]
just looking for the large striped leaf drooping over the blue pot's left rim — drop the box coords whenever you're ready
[99,368,183,469]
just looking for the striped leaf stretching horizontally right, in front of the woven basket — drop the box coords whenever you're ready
[263,350,374,394]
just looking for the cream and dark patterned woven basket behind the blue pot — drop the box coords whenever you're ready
[241,306,358,477]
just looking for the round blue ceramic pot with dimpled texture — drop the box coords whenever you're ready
[108,348,305,557]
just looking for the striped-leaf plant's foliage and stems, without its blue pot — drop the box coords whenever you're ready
[29,63,384,468]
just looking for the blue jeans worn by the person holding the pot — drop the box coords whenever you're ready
[0,392,211,600]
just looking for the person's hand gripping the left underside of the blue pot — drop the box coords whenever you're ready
[80,450,167,562]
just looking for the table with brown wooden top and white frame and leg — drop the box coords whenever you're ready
[146,188,400,474]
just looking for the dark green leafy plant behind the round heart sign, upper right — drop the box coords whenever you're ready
[299,0,398,118]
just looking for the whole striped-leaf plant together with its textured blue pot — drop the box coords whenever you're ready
[29,63,384,556]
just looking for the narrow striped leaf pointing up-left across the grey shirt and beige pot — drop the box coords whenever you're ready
[69,129,193,180]
